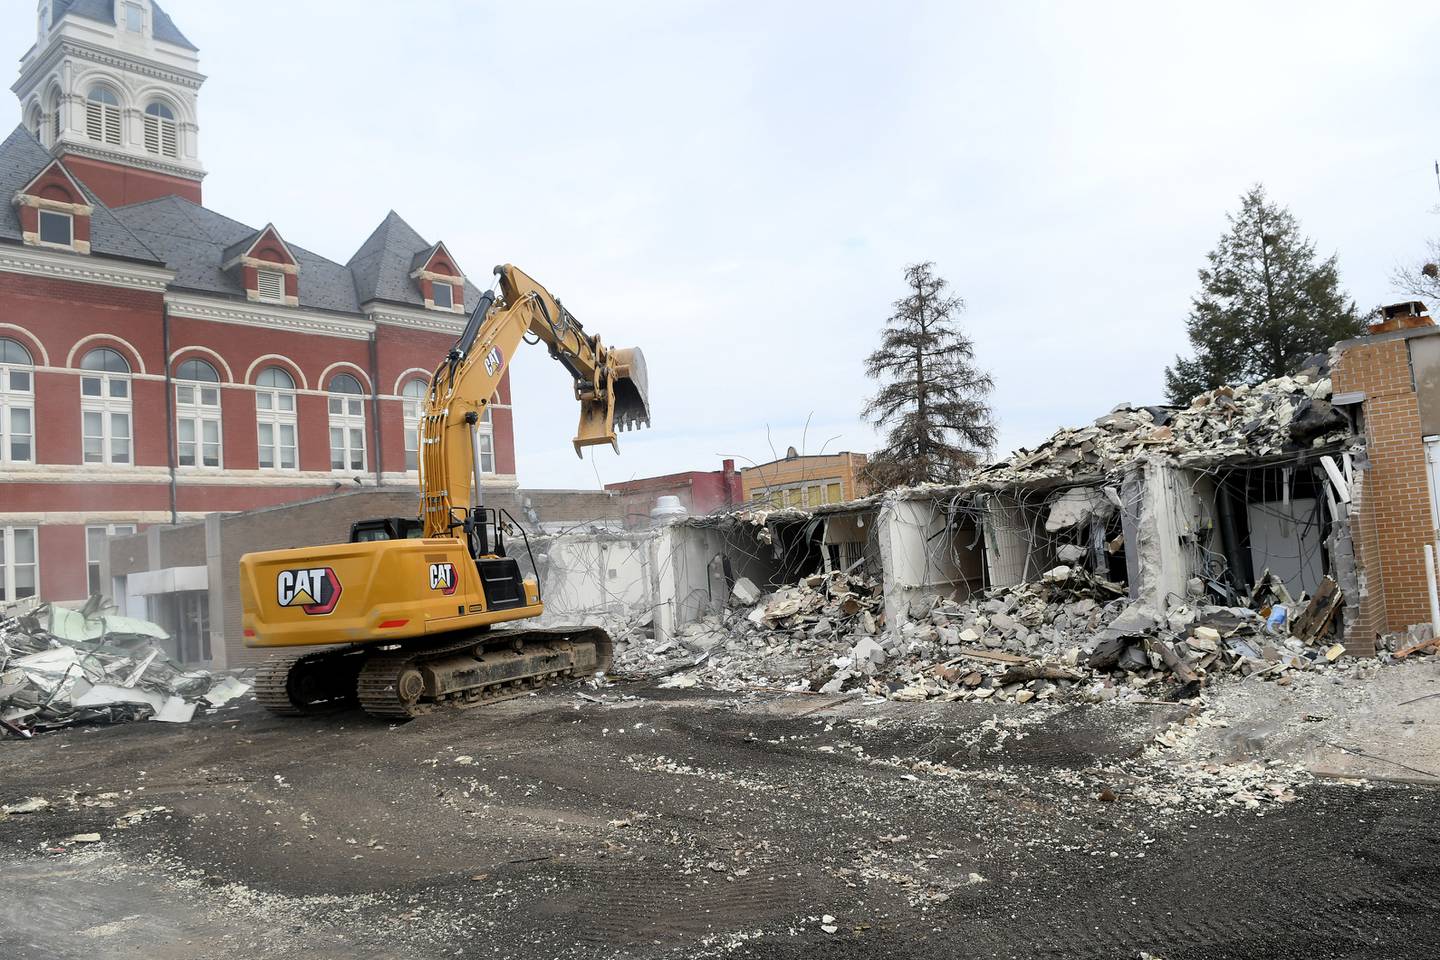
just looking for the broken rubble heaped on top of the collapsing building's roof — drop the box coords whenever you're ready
[971,366,1348,486]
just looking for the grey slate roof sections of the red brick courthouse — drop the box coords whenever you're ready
[0,125,480,314]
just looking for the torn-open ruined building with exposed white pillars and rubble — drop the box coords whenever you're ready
[529,358,1393,702]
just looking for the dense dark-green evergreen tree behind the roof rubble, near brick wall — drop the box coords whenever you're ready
[1165,184,1364,403]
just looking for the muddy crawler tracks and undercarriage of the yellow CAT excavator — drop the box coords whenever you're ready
[255,626,613,720]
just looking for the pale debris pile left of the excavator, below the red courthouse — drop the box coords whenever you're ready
[0,604,249,737]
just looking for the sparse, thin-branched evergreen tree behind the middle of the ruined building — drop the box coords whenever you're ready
[864,263,995,488]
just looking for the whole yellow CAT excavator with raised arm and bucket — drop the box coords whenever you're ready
[240,263,649,718]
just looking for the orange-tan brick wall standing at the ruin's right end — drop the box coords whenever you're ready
[1332,331,1436,652]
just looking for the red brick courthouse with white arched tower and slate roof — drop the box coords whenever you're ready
[0,0,516,602]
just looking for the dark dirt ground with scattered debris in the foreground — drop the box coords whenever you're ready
[0,679,1440,960]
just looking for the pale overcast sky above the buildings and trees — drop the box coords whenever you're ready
[14,0,1440,486]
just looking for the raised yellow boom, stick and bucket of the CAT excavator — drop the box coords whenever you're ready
[419,263,649,537]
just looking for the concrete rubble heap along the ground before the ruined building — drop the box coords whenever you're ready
[615,566,1344,704]
